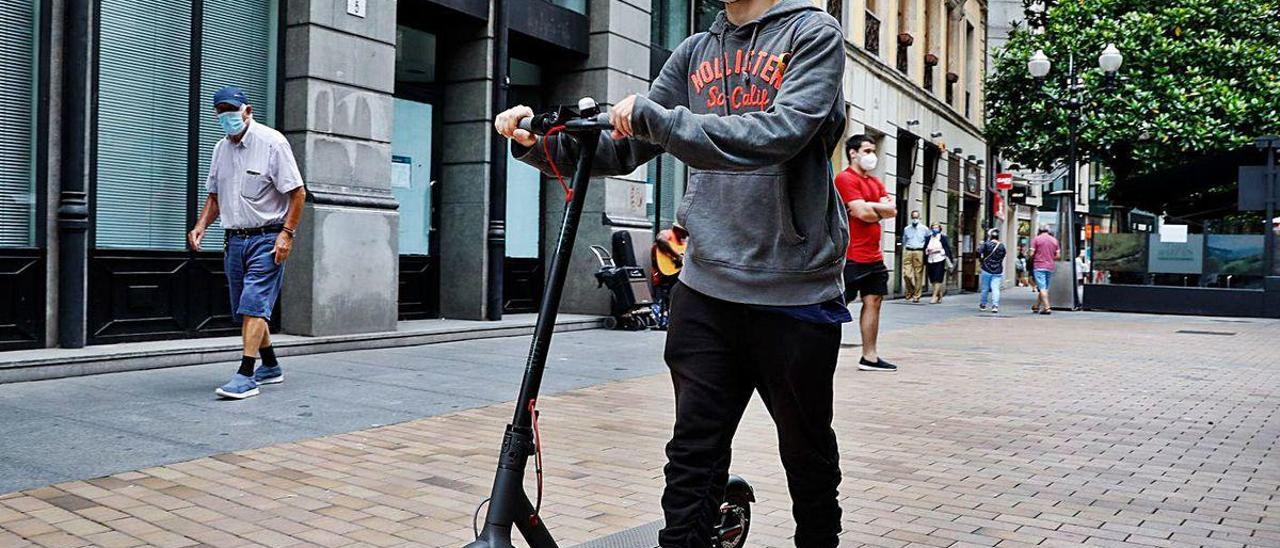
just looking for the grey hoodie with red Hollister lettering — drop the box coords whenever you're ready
[512,0,849,306]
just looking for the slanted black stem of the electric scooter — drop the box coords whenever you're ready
[466,129,600,548]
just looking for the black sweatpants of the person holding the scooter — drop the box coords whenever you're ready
[658,284,840,548]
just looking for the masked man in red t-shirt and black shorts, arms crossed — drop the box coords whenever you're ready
[836,134,897,371]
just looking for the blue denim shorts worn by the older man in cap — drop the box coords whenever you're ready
[223,233,284,323]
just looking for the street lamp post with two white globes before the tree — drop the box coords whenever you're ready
[1027,44,1124,310]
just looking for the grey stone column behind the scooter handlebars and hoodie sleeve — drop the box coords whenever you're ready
[544,0,653,314]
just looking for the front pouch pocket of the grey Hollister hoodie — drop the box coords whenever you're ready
[676,168,808,271]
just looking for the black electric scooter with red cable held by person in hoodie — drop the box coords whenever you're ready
[466,97,755,548]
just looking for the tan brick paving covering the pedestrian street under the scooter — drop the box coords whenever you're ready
[0,297,1280,547]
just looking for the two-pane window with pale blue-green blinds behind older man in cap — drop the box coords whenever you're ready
[95,0,276,251]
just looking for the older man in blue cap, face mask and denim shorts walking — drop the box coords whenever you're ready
[187,86,307,399]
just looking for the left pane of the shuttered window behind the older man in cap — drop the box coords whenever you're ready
[96,0,191,250]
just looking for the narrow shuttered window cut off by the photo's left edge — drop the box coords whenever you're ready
[0,0,38,247]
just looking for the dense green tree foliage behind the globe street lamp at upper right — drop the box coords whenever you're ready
[986,0,1280,197]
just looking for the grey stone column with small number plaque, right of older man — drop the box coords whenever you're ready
[280,0,399,335]
